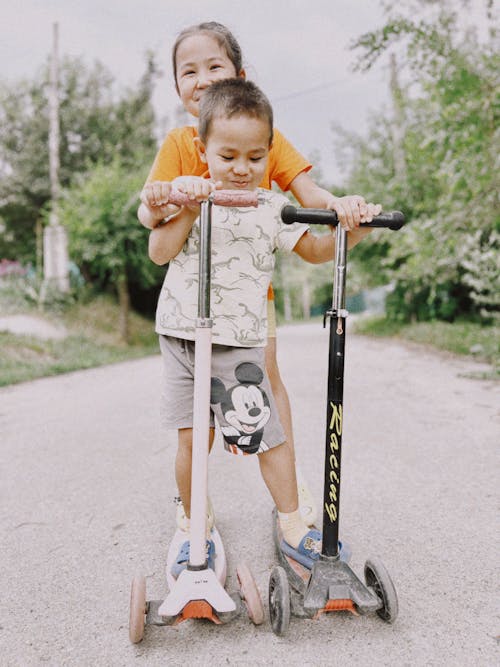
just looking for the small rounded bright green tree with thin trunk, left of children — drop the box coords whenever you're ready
[60,159,165,342]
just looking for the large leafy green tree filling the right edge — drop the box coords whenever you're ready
[340,0,500,321]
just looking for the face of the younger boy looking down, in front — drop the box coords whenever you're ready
[198,115,271,190]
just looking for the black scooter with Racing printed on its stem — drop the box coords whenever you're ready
[269,206,404,636]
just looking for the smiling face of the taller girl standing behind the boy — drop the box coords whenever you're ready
[175,33,244,117]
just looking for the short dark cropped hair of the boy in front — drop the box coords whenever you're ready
[198,78,273,145]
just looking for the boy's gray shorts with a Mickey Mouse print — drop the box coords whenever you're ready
[159,336,285,454]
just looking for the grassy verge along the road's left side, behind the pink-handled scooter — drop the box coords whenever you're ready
[0,296,158,386]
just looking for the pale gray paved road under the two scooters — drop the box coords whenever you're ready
[0,324,500,667]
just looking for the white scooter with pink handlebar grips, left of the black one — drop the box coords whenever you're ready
[129,190,264,644]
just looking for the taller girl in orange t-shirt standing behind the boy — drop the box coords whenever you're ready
[138,22,380,527]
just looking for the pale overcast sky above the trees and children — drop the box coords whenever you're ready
[0,0,492,183]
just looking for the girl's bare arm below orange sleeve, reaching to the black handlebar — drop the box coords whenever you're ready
[290,172,382,236]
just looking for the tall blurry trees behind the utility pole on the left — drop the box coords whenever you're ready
[0,56,156,263]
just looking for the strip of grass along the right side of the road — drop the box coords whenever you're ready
[355,317,500,380]
